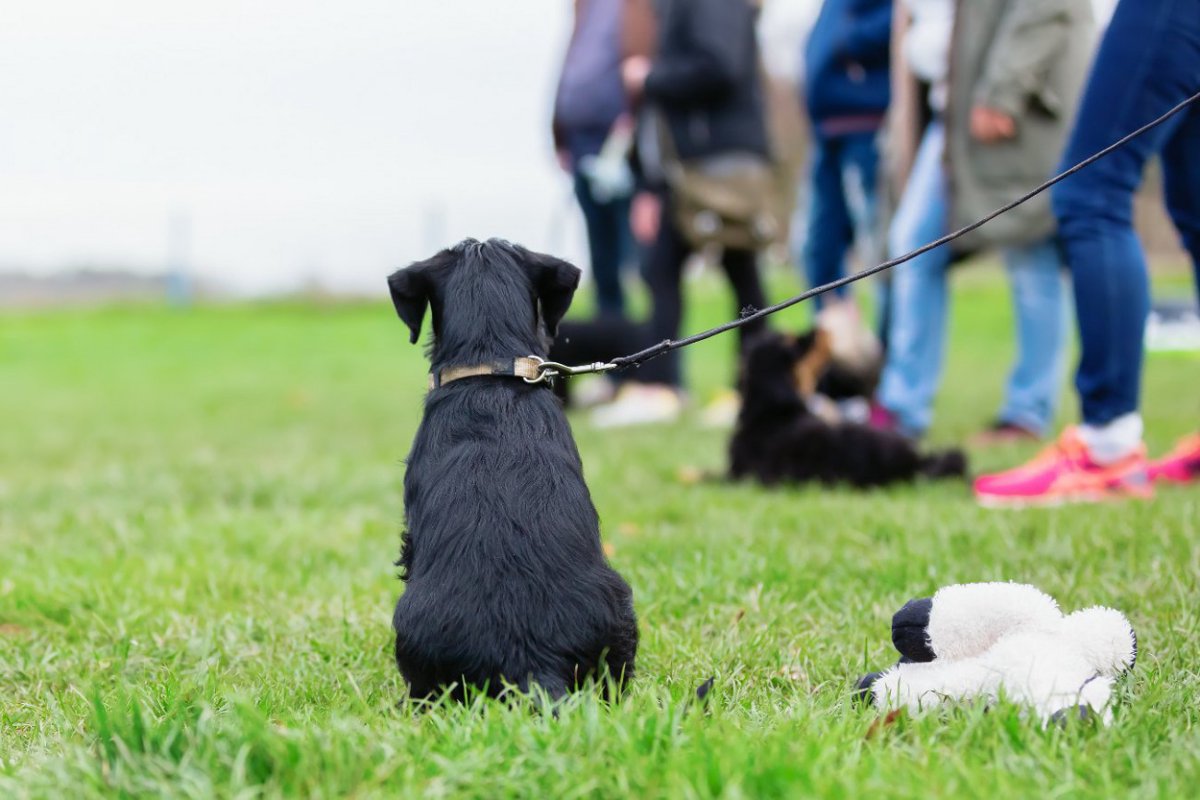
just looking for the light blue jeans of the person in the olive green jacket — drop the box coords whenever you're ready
[880,121,1067,437]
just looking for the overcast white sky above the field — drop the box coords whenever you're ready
[0,0,1109,291]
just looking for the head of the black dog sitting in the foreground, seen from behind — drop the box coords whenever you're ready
[388,239,580,361]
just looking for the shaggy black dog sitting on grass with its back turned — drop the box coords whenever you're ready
[388,240,637,699]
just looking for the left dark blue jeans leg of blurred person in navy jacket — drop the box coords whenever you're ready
[803,137,854,304]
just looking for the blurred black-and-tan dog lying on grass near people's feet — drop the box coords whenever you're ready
[730,330,966,488]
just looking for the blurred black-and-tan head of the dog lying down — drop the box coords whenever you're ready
[738,329,829,408]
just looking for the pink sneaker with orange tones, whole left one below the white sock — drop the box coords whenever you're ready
[974,428,1153,507]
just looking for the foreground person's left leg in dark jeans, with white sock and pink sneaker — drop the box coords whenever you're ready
[974,0,1200,505]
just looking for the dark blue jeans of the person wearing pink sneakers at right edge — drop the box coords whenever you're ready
[1051,0,1200,426]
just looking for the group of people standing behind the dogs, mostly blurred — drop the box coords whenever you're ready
[553,0,1200,504]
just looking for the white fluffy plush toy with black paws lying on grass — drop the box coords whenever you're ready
[858,583,1138,724]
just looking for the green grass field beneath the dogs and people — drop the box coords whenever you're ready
[0,270,1200,798]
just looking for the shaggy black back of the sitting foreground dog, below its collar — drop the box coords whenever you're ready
[394,378,636,696]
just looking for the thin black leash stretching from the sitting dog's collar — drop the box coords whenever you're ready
[530,92,1200,378]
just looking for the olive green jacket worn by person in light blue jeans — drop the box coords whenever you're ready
[893,0,1096,249]
